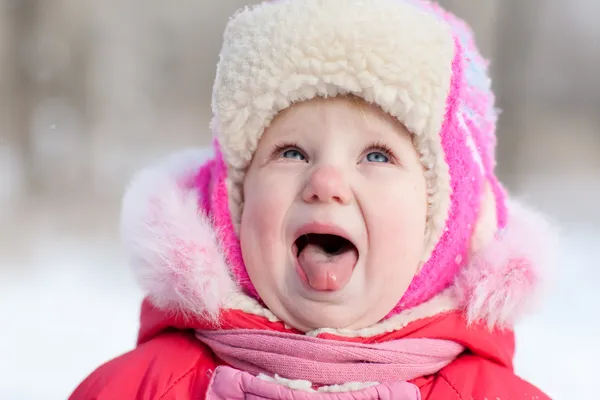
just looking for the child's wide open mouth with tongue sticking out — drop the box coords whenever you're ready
[293,233,358,291]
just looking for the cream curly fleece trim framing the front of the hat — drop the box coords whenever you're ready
[212,0,455,259]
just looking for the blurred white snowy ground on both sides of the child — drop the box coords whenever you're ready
[0,179,600,400]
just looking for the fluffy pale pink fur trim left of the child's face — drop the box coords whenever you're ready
[121,151,236,321]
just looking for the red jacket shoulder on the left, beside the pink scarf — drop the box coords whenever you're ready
[69,332,215,400]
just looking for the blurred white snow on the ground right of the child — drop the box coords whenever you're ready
[515,226,600,400]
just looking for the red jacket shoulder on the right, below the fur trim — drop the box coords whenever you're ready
[422,355,550,400]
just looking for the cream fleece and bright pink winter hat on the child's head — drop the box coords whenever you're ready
[212,0,505,311]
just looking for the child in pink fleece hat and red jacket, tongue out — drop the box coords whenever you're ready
[71,0,553,400]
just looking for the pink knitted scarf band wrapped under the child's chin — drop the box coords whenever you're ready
[196,329,464,386]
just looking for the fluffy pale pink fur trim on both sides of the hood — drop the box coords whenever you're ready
[121,148,556,337]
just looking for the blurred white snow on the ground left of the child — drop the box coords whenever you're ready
[0,200,142,400]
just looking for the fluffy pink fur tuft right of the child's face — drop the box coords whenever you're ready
[454,202,558,328]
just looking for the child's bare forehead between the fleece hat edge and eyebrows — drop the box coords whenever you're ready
[264,96,410,141]
